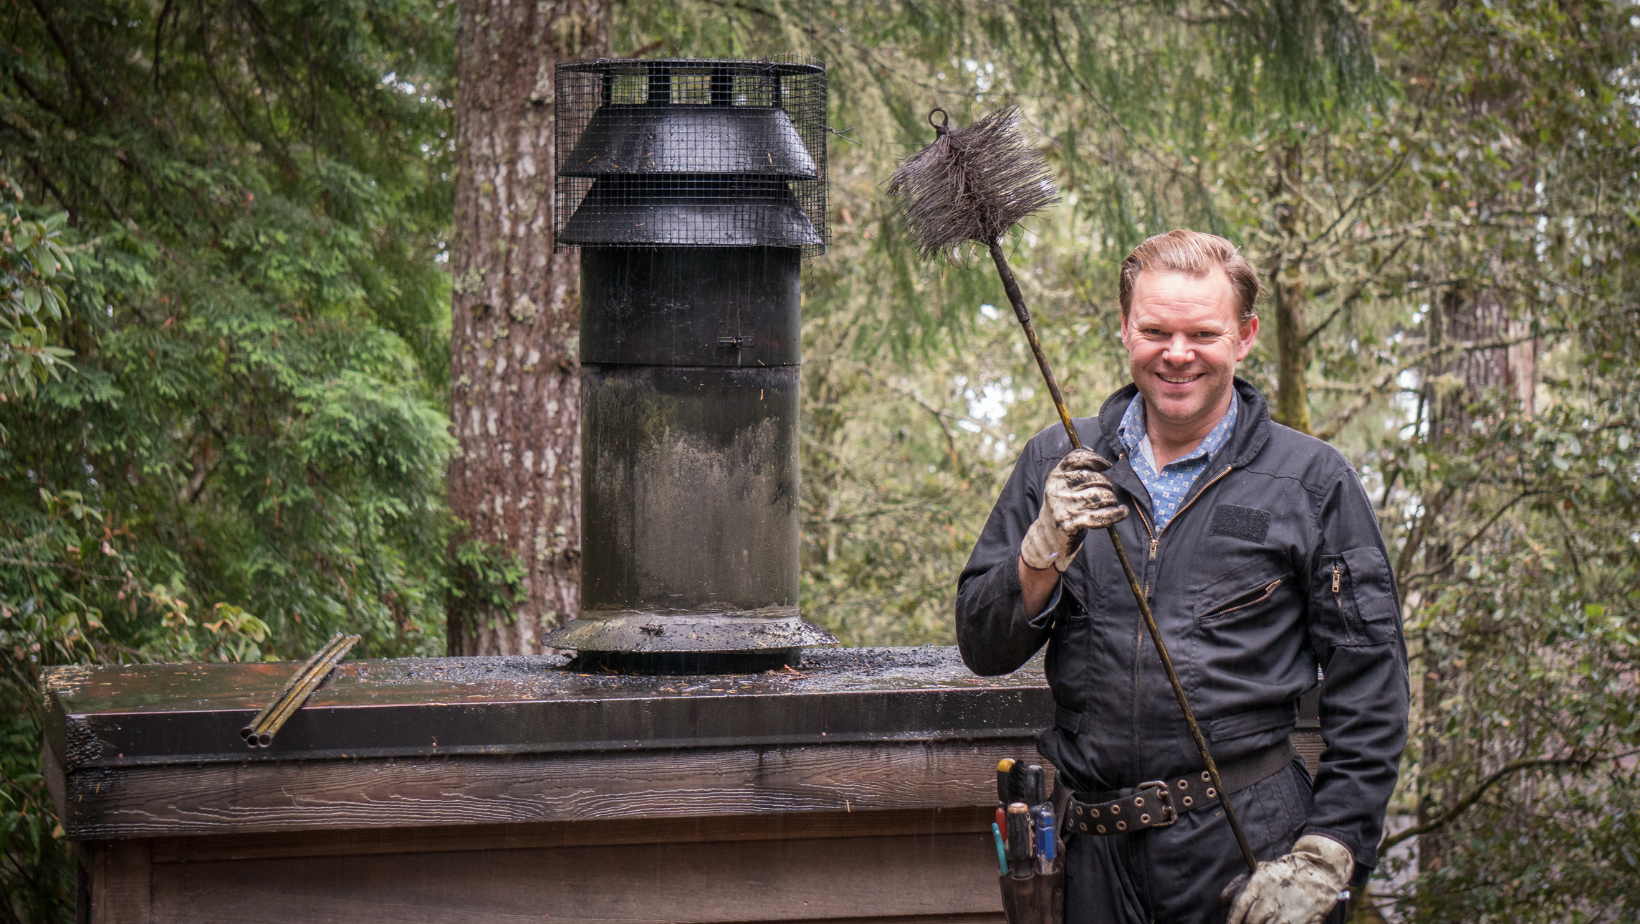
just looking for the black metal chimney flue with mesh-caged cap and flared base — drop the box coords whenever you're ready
[544,61,835,673]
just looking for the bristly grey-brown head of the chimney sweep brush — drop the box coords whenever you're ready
[889,107,1059,258]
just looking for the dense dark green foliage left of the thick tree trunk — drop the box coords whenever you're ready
[0,0,454,921]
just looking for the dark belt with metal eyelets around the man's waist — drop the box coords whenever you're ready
[1061,739,1297,835]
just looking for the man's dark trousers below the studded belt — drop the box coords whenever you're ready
[1064,760,1345,924]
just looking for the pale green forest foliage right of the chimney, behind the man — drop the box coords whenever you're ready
[617,0,1640,922]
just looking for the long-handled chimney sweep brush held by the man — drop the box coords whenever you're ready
[889,107,1258,888]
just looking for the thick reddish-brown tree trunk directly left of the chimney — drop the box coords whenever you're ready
[448,0,608,655]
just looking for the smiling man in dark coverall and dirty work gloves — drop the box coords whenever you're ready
[956,231,1409,924]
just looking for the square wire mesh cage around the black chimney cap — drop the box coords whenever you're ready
[553,57,830,256]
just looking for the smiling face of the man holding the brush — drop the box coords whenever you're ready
[1122,268,1258,440]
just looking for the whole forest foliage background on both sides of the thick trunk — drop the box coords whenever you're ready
[0,0,1640,922]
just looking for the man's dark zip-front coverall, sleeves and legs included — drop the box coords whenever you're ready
[956,379,1409,924]
